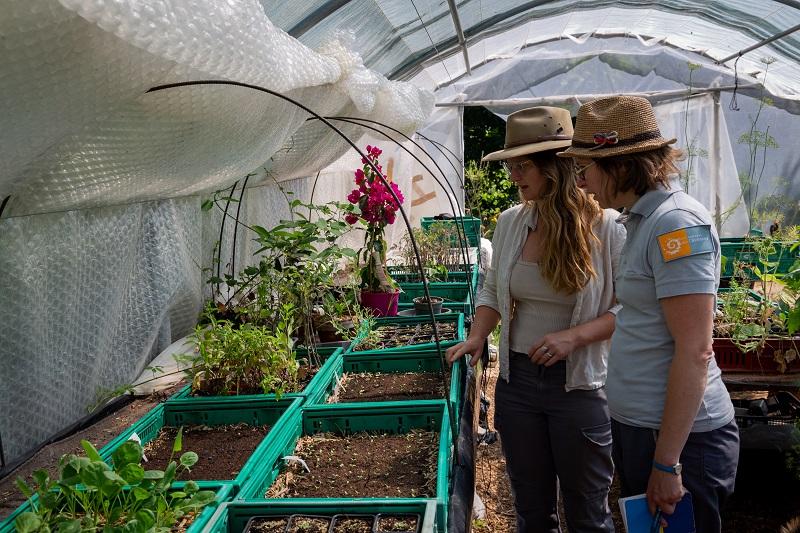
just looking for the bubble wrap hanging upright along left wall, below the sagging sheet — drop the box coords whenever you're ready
[0,198,202,461]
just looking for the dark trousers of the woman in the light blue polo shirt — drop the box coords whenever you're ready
[611,420,739,533]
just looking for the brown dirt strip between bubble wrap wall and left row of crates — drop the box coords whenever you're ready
[0,383,185,520]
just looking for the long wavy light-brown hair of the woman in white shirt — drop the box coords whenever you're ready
[526,151,602,294]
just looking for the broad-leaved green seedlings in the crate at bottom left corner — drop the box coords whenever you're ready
[15,430,216,533]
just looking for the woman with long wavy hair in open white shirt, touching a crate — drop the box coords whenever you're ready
[447,107,625,533]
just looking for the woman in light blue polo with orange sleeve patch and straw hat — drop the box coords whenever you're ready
[559,96,739,532]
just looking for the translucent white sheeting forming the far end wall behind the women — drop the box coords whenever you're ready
[431,37,800,236]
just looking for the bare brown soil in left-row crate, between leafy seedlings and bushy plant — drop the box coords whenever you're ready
[144,424,270,481]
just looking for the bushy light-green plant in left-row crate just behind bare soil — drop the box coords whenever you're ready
[176,303,300,398]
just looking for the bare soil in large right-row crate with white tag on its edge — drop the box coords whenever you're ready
[267,431,439,498]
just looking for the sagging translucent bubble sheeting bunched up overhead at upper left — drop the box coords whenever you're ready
[0,0,433,216]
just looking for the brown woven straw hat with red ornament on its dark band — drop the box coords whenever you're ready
[558,96,677,159]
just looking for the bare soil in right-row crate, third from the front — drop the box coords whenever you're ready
[337,372,444,403]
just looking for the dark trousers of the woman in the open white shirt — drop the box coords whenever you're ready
[495,351,614,533]
